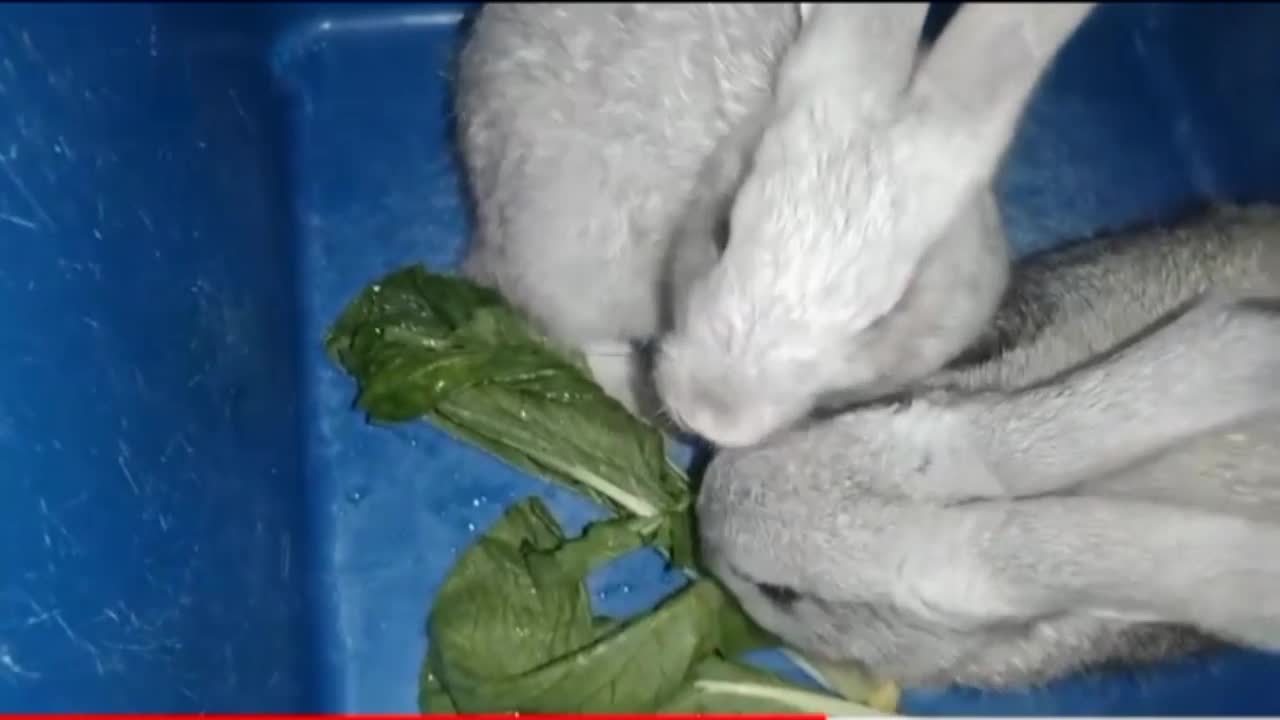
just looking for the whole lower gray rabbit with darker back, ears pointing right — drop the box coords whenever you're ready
[698,208,1280,687]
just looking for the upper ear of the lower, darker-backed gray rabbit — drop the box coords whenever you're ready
[940,296,1280,496]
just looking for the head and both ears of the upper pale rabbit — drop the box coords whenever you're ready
[654,3,1093,447]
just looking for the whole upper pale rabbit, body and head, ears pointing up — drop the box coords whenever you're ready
[457,3,1092,427]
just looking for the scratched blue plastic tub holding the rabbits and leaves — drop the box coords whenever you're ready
[0,3,1280,714]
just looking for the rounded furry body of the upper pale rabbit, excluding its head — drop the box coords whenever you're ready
[457,3,800,410]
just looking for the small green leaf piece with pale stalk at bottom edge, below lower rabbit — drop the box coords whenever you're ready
[657,657,883,716]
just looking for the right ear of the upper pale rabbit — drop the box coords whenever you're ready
[909,3,1096,183]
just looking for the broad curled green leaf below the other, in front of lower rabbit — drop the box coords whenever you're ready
[430,498,728,712]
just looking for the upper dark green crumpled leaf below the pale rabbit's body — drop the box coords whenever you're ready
[325,266,691,515]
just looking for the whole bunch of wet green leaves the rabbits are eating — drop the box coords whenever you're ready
[326,266,896,715]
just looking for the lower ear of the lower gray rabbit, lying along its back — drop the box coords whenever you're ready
[916,496,1280,651]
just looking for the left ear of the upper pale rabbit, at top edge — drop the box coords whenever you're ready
[777,3,929,118]
